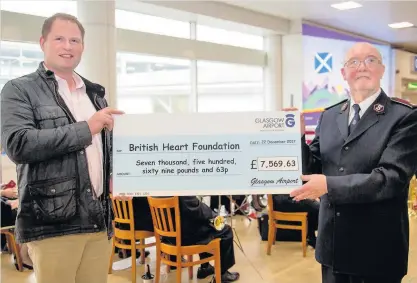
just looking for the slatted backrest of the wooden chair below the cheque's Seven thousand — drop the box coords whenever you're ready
[148,196,181,247]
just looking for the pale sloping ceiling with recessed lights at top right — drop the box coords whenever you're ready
[222,0,417,53]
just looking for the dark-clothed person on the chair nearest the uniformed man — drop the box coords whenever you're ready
[273,195,320,248]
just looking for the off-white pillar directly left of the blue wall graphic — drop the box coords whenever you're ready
[281,21,304,110]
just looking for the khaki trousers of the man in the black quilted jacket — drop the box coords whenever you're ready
[28,232,112,283]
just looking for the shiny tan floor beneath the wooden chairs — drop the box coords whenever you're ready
[1,214,417,283]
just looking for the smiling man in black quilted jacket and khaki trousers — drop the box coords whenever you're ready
[1,14,122,283]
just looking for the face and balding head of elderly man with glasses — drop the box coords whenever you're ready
[342,43,385,91]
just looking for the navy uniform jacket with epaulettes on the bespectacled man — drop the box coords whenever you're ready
[303,91,417,278]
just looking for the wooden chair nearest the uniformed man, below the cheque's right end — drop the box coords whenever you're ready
[266,195,307,257]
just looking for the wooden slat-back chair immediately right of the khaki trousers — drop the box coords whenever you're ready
[109,195,155,283]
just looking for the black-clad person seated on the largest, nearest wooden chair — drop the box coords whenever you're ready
[164,196,239,283]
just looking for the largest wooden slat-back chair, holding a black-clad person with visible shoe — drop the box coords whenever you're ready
[148,197,221,283]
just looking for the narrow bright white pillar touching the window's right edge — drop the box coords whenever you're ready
[264,35,282,111]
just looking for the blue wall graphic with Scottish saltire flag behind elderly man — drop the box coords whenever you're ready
[303,24,393,110]
